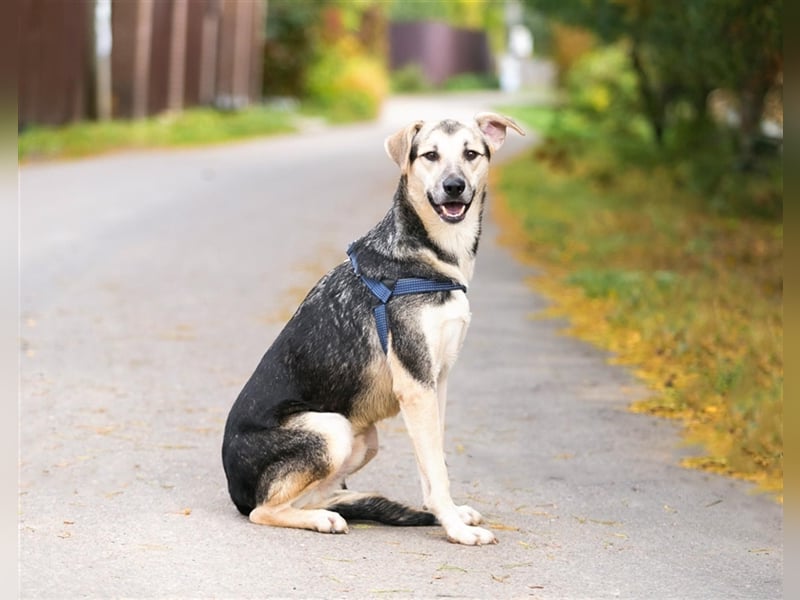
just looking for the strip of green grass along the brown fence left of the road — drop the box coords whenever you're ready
[17,106,296,161]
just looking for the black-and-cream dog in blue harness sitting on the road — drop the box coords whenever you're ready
[222,112,525,545]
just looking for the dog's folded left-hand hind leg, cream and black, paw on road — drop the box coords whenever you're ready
[250,412,353,533]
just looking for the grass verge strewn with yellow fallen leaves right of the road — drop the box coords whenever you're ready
[495,103,783,499]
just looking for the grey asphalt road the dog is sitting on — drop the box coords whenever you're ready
[20,95,783,599]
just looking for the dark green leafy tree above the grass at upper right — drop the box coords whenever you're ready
[527,0,783,165]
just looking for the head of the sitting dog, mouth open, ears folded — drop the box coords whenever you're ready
[385,112,525,225]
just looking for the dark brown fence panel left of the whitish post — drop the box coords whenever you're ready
[18,0,92,127]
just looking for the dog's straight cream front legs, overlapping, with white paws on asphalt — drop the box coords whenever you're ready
[393,366,497,546]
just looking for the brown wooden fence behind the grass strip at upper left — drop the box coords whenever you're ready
[18,0,266,127]
